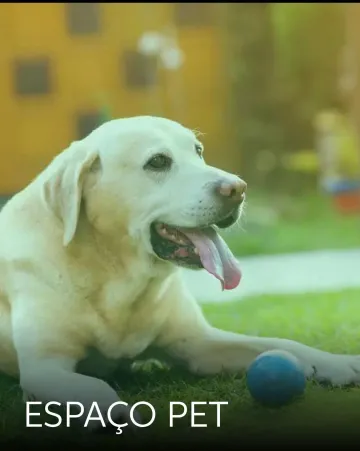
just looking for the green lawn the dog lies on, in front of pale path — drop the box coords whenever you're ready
[0,290,360,440]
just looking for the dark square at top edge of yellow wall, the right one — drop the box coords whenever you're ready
[174,3,213,27]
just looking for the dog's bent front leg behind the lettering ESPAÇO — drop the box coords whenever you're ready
[12,304,140,432]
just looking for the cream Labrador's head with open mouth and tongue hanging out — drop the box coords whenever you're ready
[43,116,246,288]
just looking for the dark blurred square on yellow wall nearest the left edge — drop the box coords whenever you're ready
[13,58,51,96]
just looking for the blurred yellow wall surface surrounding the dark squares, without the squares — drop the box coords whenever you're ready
[0,3,231,194]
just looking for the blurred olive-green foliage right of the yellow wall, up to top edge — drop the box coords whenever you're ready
[226,3,344,190]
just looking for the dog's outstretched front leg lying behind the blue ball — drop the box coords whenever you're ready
[168,328,360,386]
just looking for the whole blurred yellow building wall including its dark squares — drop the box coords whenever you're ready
[0,3,234,194]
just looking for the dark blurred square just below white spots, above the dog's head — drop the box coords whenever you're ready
[123,50,157,88]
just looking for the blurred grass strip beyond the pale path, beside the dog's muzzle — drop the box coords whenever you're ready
[223,194,360,256]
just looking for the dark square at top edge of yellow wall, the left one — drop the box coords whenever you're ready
[65,3,100,35]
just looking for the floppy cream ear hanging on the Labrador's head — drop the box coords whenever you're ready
[43,141,100,246]
